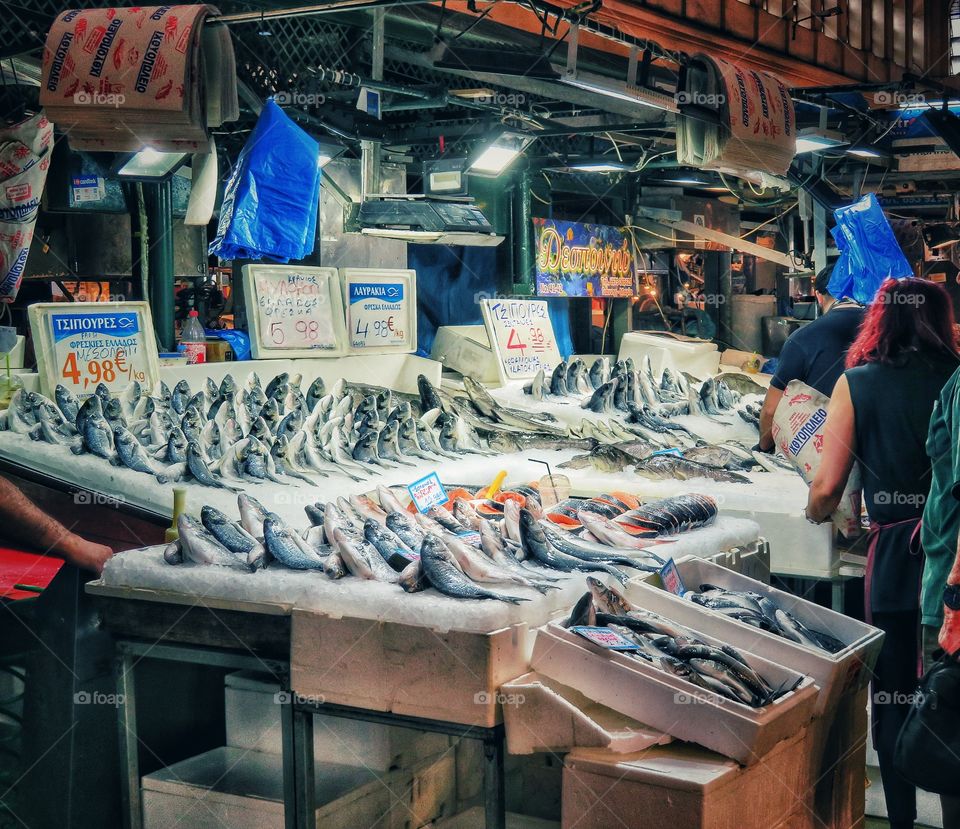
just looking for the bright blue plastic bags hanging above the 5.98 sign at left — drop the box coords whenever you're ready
[210,101,320,262]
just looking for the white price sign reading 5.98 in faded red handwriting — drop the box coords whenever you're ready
[243,265,344,359]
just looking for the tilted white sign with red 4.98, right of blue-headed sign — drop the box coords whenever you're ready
[482,299,563,383]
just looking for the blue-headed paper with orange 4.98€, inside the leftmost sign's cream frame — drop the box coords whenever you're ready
[50,311,149,394]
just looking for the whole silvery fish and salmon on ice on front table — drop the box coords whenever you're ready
[164,478,716,603]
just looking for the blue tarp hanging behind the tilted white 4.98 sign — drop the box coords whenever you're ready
[407,245,576,357]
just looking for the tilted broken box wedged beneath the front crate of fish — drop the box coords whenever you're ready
[501,673,670,754]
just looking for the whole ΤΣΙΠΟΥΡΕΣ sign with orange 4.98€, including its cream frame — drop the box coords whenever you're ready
[29,302,159,396]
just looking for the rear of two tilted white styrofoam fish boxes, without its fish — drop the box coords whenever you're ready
[626,557,883,716]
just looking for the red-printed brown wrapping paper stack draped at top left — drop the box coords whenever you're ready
[40,5,237,152]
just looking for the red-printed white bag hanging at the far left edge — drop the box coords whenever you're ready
[0,112,53,302]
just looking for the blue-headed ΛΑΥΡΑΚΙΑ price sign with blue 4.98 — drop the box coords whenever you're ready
[341,268,417,354]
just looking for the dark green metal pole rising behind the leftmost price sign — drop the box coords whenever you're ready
[143,181,176,351]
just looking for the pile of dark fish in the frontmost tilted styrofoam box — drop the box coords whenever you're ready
[565,577,803,708]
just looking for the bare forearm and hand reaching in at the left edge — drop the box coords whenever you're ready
[0,477,113,573]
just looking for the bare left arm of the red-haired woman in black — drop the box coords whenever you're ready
[807,377,856,521]
